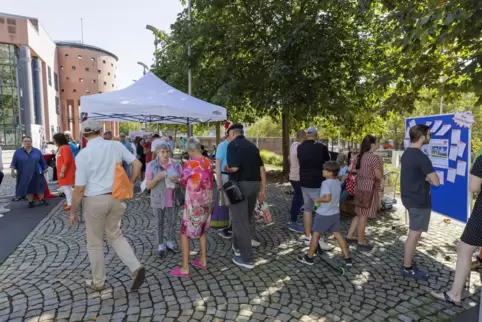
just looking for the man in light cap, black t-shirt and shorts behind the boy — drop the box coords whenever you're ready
[297,126,333,250]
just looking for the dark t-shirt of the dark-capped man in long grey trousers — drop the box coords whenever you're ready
[227,135,264,181]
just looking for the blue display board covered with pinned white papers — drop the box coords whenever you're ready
[404,114,472,222]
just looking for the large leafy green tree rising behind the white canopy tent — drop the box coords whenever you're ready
[155,0,388,174]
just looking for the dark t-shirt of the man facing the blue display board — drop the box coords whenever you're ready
[400,148,435,209]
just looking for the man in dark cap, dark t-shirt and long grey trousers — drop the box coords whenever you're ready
[225,124,266,269]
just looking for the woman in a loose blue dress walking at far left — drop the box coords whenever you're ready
[10,136,48,208]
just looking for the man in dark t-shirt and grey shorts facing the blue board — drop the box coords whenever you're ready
[400,125,440,279]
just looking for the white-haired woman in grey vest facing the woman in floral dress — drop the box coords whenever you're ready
[146,143,182,258]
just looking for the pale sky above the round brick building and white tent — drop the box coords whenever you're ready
[0,0,182,88]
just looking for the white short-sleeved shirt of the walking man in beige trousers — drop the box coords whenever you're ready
[75,137,136,197]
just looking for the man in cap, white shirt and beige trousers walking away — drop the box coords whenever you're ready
[70,120,146,291]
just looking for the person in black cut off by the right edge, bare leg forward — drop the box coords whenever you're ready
[431,156,482,306]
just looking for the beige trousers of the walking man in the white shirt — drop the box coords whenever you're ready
[82,195,141,286]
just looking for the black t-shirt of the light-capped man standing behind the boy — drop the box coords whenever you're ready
[298,140,330,188]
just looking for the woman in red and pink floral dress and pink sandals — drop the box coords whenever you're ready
[171,138,214,277]
